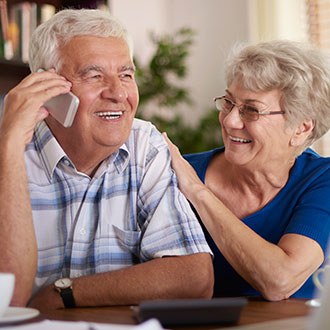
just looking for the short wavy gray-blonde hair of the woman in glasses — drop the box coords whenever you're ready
[226,40,330,154]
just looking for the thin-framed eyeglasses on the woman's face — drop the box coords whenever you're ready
[214,96,285,121]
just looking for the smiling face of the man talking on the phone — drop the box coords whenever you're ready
[47,35,139,159]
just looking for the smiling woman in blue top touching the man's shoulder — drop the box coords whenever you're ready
[164,41,330,300]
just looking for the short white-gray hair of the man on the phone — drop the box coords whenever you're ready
[29,9,133,72]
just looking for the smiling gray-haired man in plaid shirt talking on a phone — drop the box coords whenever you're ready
[0,9,213,309]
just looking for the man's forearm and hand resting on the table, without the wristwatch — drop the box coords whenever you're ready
[31,253,214,310]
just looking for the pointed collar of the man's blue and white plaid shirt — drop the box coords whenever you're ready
[34,121,130,182]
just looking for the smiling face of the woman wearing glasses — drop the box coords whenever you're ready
[219,81,293,168]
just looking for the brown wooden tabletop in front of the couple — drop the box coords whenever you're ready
[12,297,312,330]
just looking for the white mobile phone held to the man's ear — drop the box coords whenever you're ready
[38,69,79,127]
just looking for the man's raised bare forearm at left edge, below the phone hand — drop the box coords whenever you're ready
[0,139,37,306]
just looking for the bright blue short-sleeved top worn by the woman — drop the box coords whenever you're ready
[184,147,330,298]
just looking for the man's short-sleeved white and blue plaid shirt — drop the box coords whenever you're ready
[25,119,211,293]
